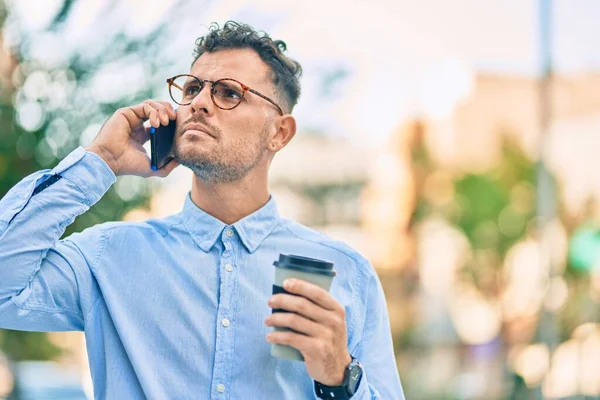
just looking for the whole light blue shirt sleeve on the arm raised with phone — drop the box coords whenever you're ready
[0,147,116,331]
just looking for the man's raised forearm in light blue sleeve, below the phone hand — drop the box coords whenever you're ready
[0,148,115,302]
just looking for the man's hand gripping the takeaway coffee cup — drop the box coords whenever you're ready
[265,279,352,386]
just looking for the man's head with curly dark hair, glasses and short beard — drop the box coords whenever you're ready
[171,21,301,183]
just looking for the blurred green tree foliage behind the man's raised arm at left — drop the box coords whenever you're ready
[0,0,191,360]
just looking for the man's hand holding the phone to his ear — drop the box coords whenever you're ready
[86,100,179,177]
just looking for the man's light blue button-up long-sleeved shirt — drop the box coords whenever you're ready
[0,147,404,400]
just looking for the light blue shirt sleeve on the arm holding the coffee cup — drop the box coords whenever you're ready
[350,263,404,400]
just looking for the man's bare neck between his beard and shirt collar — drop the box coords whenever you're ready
[191,170,269,225]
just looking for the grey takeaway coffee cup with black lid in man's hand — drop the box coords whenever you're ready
[271,254,335,361]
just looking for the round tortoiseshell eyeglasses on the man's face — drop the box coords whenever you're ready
[167,74,283,115]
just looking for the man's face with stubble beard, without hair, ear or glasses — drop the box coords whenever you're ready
[174,49,279,183]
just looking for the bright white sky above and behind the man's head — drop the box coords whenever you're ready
[4,0,600,145]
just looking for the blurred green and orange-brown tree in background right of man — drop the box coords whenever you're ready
[412,129,535,294]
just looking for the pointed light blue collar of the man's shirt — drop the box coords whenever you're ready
[182,193,279,253]
